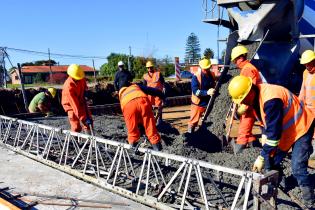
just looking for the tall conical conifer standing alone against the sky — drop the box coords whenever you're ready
[185,33,201,64]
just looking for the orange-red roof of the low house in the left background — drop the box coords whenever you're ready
[12,65,94,73]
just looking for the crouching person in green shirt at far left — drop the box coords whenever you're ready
[28,88,57,117]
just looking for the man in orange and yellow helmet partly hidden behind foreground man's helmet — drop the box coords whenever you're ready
[231,45,262,154]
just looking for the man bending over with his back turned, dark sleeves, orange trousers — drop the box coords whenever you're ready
[119,81,164,151]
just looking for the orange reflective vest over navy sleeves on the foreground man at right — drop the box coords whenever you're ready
[258,84,314,152]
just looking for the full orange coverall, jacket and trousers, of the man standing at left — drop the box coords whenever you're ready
[61,77,91,132]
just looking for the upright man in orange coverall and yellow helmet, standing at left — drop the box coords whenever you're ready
[61,64,93,134]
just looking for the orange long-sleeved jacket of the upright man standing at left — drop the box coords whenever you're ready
[61,77,88,121]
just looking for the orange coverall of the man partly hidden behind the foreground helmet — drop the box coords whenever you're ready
[236,60,262,145]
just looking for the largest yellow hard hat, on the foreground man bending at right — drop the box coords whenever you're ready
[228,76,253,104]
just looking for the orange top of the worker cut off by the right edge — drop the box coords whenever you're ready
[299,70,315,114]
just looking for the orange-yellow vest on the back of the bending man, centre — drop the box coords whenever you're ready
[119,85,147,110]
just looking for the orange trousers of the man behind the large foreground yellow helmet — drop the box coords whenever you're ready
[236,107,256,145]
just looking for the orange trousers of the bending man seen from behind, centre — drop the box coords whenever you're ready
[123,97,161,144]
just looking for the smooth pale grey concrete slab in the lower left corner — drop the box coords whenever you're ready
[0,146,151,210]
